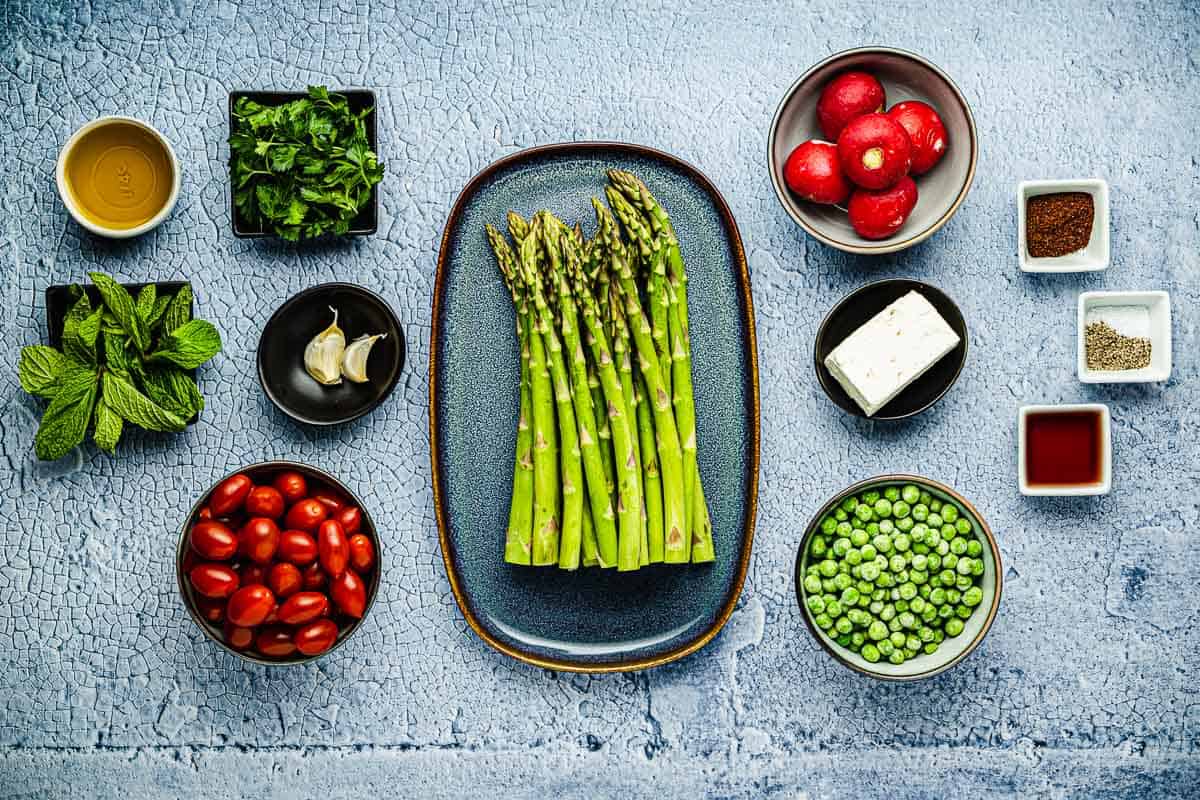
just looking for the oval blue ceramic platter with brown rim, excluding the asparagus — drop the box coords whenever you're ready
[430,143,758,672]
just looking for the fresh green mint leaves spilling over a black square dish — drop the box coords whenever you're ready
[17,272,221,461]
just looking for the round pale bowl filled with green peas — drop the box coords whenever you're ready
[796,475,1002,680]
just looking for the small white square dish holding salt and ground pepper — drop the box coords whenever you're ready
[1076,291,1171,384]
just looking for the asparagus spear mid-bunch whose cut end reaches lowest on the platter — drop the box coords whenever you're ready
[556,234,617,566]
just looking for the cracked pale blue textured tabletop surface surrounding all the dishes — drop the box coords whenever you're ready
[0,0,1200,800]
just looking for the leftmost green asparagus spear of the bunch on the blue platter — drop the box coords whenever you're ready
[487,225,533,565]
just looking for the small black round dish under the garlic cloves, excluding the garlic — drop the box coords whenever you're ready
[258,283,404,425]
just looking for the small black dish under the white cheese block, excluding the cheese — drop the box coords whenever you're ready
[812,278,967,420]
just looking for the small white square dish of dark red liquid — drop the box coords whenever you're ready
[1016,403,1112,497]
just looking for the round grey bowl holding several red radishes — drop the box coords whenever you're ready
[767,47,978,254]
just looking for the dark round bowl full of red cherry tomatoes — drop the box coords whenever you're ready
[175,461,380,666]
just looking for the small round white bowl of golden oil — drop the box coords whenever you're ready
[64,120,175,230]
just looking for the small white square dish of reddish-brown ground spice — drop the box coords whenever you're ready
[1016,178,1109,272]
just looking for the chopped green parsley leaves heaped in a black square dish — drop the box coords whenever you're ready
[229,86,383,241]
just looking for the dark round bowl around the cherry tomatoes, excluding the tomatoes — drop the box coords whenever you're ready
[175,461,383,667]
